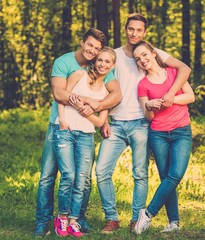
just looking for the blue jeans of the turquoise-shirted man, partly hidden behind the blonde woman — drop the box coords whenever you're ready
[36,123,92,231]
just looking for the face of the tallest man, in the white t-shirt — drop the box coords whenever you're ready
[125,20,146,45]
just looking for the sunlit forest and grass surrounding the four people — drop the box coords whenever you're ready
[0,0,205,240]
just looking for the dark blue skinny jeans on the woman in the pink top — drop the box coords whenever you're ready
[147,125,192,222]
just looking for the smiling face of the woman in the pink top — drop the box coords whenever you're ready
[133,45,156,70]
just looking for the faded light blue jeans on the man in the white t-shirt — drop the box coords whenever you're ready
[96,118,149,221]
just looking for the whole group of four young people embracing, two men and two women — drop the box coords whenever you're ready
[35,13,195,237]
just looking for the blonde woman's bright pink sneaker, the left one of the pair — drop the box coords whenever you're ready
[54,216,70,237]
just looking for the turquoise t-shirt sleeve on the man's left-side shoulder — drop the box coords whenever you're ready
[51,58,70,78]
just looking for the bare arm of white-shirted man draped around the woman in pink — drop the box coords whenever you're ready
[163,56,191,107]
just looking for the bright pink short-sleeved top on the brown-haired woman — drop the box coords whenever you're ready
[138,68,190,131]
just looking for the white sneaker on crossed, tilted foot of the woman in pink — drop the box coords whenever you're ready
[135,209,152,234]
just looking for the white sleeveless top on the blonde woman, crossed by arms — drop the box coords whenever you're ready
[55,71,107,133]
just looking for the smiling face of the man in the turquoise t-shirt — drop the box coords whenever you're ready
[81,36,102,61]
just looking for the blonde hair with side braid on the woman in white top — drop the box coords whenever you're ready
[88,46,117,84]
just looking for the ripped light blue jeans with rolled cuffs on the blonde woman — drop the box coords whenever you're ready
[53,125,94,219]
